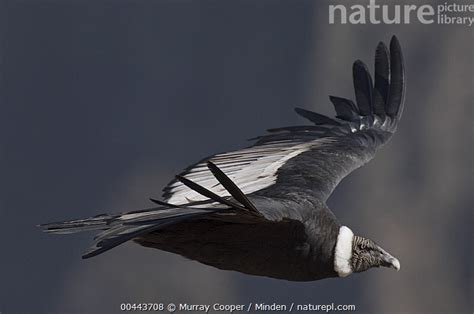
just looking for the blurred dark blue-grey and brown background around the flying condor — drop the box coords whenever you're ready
[0,0,474,314]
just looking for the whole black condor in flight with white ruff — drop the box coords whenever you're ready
[40,37,405,281]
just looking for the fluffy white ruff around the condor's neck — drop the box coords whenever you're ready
[334,226,354,277]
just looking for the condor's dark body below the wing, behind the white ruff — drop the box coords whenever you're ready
[135,196,339,281]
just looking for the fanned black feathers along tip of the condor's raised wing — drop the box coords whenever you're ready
[251,36,405,151]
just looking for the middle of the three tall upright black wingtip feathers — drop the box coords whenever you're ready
[373,42,390,119]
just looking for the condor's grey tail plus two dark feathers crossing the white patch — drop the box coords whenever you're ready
[39,163,261,258]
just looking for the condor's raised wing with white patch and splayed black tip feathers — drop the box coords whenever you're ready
[163,36,405,204]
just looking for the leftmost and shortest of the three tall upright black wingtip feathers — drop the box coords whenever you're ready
[352,60,373,116]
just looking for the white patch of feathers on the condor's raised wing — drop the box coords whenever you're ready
[165,139,328,205]
